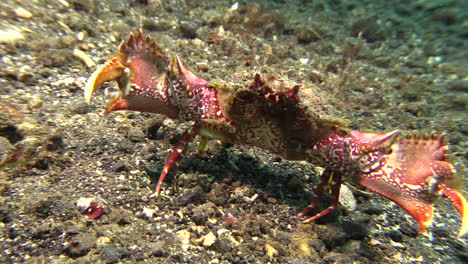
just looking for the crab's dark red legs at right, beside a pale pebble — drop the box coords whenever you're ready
[299,169,341,223]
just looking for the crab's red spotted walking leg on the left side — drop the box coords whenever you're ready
[151,125,199,198]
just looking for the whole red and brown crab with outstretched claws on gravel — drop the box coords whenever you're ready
[85,30,468,236]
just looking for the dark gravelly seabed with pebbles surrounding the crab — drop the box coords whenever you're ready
[0,0,468,263]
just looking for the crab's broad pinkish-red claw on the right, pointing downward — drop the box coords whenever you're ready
[355,134,468,236]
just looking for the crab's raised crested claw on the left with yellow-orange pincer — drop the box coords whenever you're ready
[84,31,179,118]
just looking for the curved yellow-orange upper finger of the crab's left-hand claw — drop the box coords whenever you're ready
[84,57,125,104]
